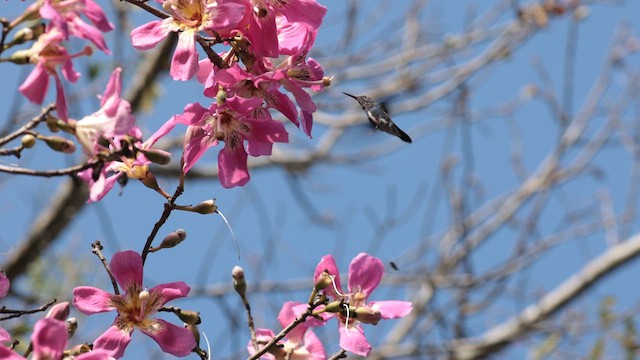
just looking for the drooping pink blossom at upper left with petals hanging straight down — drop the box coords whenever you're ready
[18,28,91,120]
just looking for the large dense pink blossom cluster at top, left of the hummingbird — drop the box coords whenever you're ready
[136,0,330,188]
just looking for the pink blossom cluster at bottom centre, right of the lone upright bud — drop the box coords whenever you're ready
[247,253,413,360]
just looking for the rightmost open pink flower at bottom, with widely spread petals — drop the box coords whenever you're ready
[314,253,413,356]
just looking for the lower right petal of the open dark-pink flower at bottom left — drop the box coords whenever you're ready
[140,319,196,356]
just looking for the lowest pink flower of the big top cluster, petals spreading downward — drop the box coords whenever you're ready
[152,96,289,188]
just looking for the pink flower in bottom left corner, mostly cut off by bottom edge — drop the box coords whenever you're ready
[0,318,111,360]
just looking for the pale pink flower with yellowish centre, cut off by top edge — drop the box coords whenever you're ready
[131,0,246,80]
